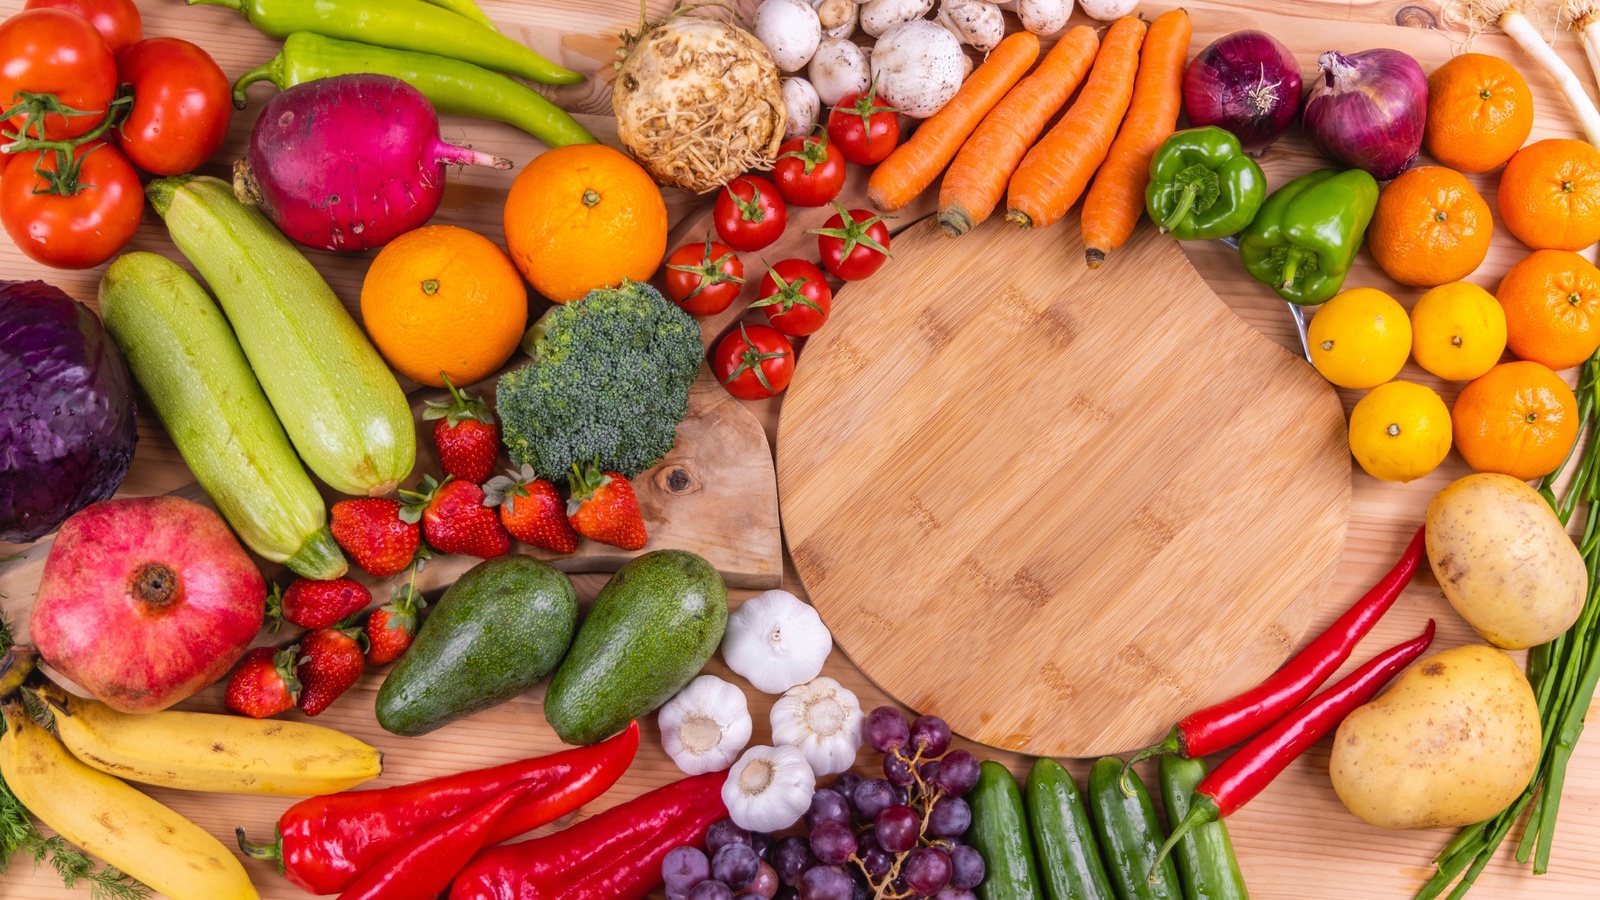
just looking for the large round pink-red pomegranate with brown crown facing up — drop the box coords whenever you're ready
[30,496,267,713]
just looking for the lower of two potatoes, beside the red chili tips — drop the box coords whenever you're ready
[1328,644,1539,828]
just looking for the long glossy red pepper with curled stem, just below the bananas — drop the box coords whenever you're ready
[237,722,638,894]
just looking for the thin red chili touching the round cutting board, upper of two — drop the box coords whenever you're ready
[1122,528,1422,775]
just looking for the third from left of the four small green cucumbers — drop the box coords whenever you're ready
[1090,756,1184,900]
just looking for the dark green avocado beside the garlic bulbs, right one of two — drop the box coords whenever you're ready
[544,549,728,745]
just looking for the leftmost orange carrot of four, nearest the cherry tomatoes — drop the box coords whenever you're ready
[867,32,1038,211]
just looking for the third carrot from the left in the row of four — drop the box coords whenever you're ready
[1005,16,1144,227]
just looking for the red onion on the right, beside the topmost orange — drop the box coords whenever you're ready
[1304,50,1427,181]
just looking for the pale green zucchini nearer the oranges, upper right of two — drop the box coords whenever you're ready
[144,175,416,496]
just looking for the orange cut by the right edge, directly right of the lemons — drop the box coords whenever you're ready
[1494,250,1600,368]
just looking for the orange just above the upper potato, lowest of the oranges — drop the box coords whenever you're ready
[1451,360,1578,480]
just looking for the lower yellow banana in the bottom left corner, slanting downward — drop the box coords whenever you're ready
[0,700,261,900]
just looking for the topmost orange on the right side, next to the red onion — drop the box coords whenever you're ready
[1422,53,1533,173]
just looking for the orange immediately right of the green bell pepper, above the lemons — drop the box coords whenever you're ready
[1366,165,1494,287]
